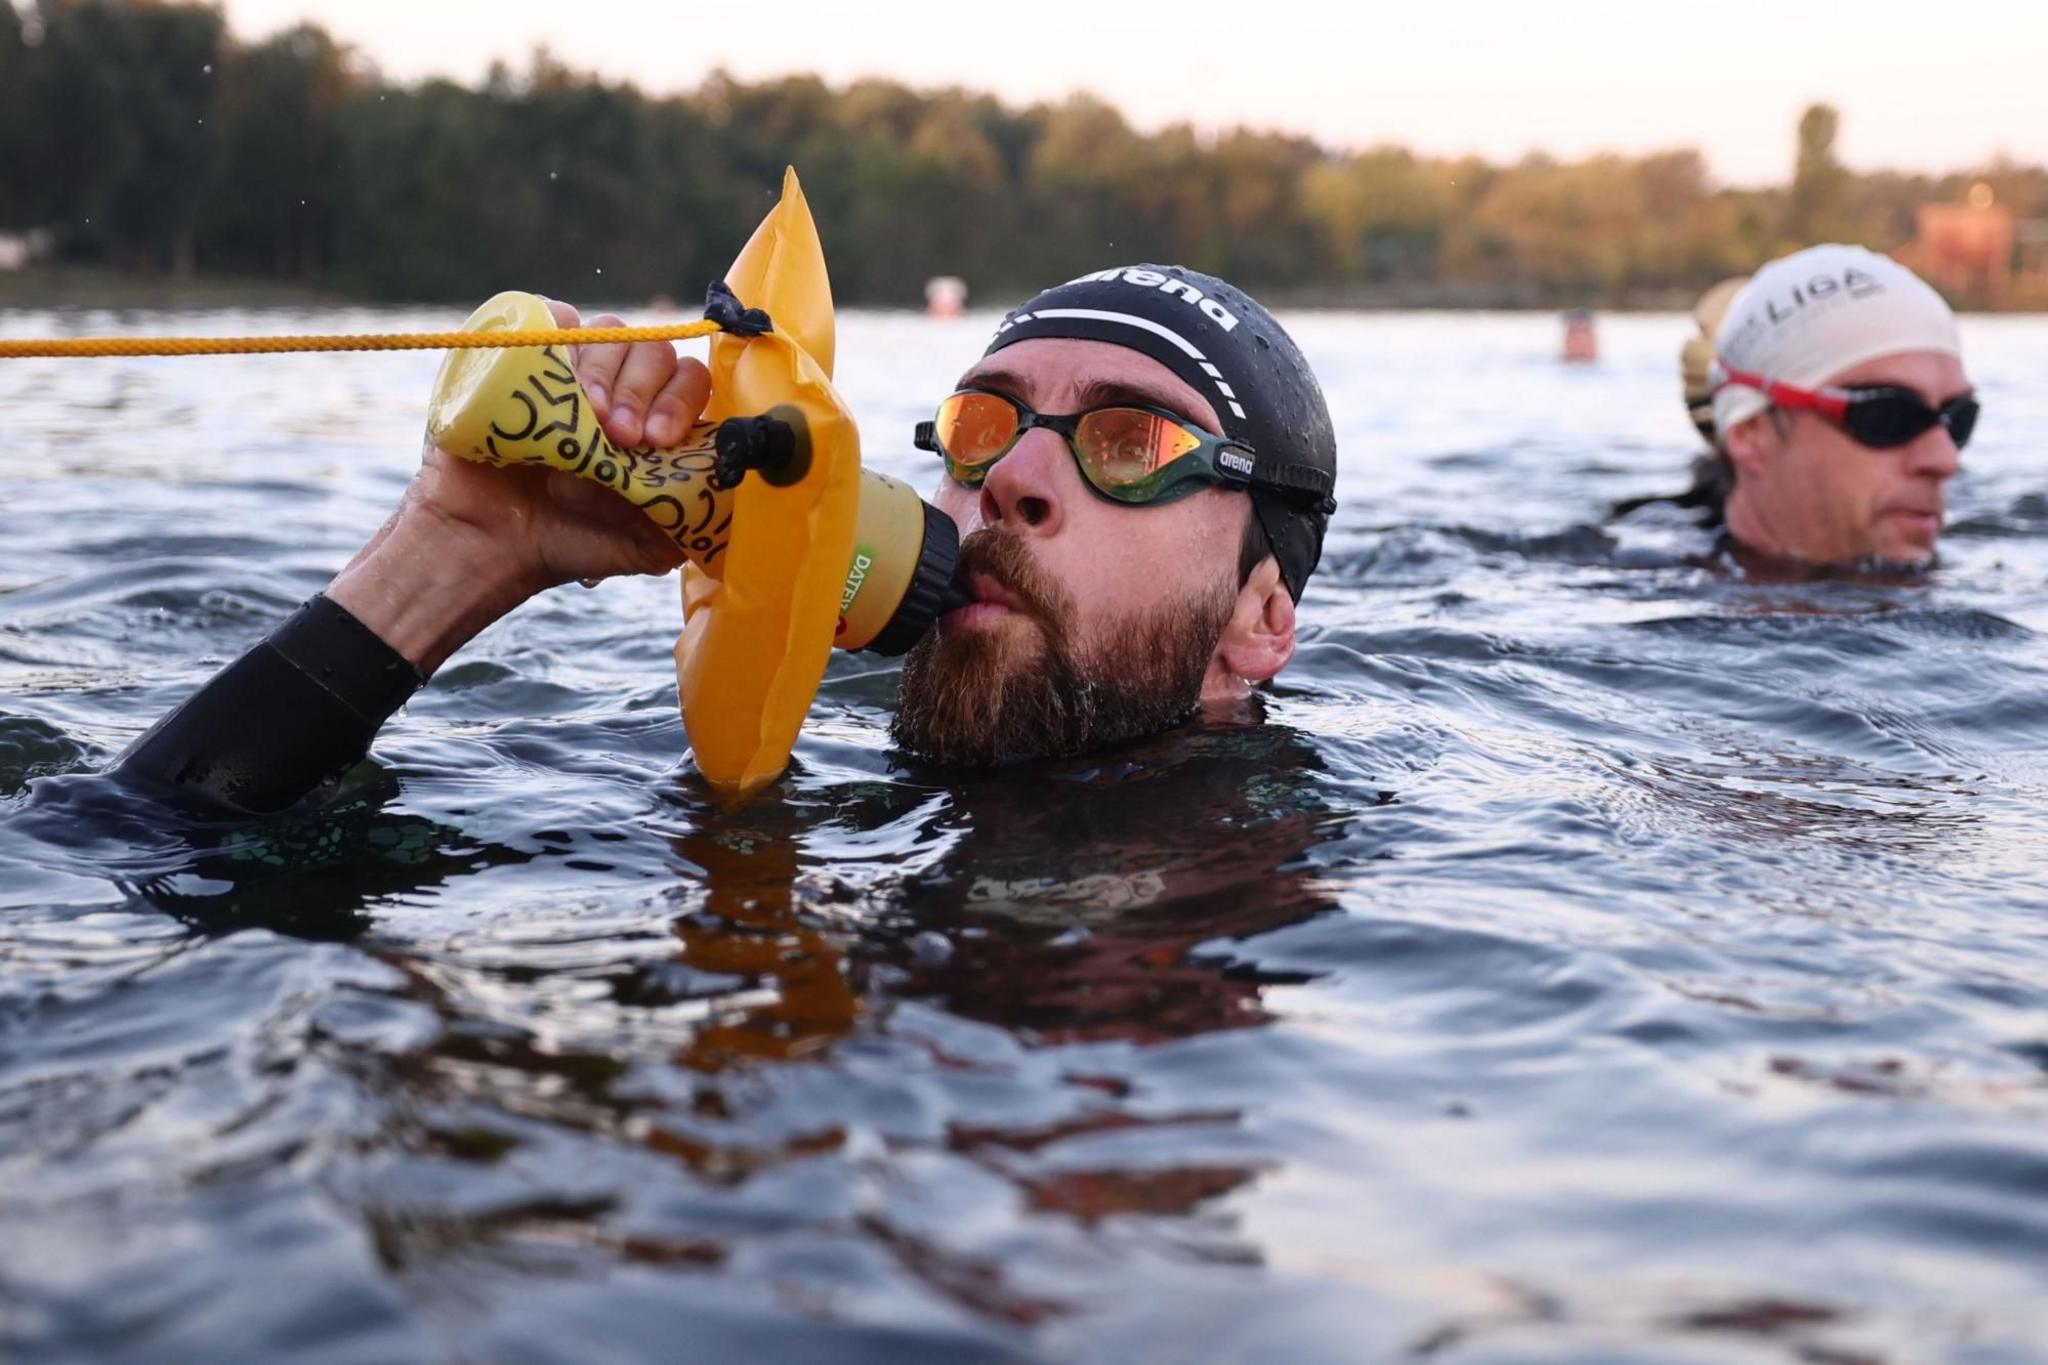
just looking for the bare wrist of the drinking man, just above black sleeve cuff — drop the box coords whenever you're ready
[326,503,539,675]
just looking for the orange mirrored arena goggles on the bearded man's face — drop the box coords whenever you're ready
[913,389,1278,505]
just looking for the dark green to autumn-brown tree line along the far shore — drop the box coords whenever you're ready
[0,0,2048,305]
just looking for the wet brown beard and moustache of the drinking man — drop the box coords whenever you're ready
[889,530,1235,767]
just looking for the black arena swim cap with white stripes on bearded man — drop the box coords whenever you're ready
[983,266,1337,602]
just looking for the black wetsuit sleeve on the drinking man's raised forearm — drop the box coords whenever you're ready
[115,596,426,812]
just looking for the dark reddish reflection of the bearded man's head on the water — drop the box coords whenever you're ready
[884,726,1335,1044]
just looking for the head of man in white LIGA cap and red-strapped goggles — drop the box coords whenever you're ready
[1710,246,1978,571]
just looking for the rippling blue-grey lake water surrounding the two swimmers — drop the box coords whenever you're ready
[0,309,2048,1365]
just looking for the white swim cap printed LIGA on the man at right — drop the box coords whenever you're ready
[1714,244,1962,434]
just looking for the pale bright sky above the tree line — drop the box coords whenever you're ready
[225,0,2048,184]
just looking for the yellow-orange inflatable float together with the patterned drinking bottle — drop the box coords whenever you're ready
[428,170,958,796]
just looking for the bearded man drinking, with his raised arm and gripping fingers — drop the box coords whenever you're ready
[117,266,1337,812]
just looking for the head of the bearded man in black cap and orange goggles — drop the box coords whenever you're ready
[893,266,1335,765]
